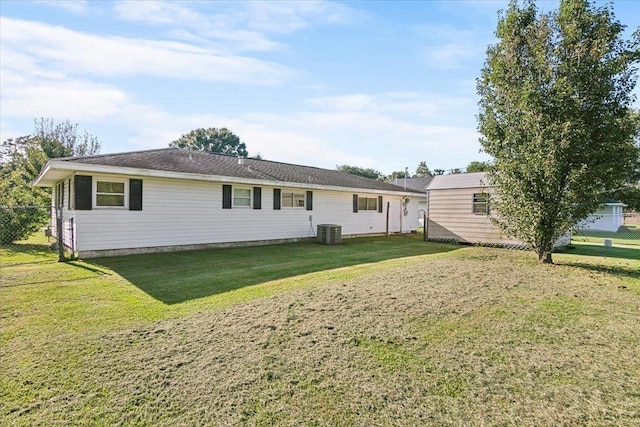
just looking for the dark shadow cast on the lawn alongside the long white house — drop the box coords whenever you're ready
[90,236,457,304]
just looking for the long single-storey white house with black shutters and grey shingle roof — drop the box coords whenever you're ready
[36,148,419,258]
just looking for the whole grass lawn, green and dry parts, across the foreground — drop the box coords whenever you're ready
[0,235,640,426]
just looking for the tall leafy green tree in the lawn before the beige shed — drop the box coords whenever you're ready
[477,0,640,263]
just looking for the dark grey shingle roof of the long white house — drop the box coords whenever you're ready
[56,148,415,192]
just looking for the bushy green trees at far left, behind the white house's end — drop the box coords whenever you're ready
[0,119,100,244]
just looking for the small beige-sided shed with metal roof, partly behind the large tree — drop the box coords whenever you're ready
[427,172,571,247]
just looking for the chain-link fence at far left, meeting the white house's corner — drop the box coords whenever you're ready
[0,206,75,265]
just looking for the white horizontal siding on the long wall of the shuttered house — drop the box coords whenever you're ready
[74,177,417,255]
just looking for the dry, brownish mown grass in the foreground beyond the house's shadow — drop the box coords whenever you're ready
[2,248,640,426]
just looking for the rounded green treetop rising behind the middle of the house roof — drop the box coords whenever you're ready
[169,128,249,157]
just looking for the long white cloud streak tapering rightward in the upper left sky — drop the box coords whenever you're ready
[0,18,293,85]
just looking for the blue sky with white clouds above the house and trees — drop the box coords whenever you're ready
[0,0,640,174]
